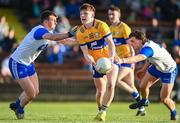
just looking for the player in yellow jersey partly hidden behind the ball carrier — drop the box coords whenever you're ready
[108,6,146,116]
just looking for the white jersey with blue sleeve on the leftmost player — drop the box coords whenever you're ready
[11,25,49,65]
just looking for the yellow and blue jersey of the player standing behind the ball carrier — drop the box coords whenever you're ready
[110,22,132,58]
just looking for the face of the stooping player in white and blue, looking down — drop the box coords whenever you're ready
[126,37,142,51]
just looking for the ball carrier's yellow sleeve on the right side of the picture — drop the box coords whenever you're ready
[99,23,111,37]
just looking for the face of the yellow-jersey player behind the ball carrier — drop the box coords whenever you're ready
[108,10,120,23]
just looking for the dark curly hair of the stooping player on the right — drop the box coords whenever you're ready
[129,30,148,44]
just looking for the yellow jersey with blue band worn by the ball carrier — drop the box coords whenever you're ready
[76,19,111,62]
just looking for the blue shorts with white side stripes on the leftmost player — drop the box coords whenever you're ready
[9,58,36,79]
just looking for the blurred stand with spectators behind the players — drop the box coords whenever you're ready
[0,0,180,101]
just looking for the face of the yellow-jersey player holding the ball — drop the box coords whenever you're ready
[80,10,94,24]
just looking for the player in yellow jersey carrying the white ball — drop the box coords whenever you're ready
[76,3,119,121]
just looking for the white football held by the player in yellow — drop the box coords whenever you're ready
[95,57,111,74]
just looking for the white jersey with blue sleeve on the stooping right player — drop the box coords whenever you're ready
[140,41,176,73]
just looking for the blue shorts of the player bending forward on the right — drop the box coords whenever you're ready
[148,65,178,83]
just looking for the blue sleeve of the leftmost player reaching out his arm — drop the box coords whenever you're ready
[34,28,49,40]
